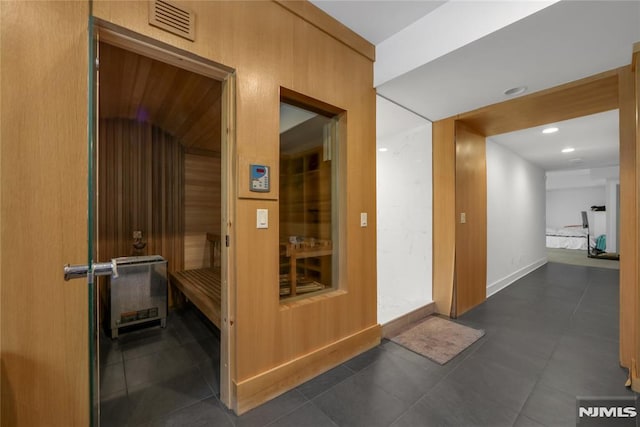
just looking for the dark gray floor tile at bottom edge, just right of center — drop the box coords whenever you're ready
[312,375,409,427]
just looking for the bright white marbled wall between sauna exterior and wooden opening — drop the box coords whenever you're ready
[376,97,433,324]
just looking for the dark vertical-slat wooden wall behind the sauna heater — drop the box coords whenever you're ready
[98,119,184,271]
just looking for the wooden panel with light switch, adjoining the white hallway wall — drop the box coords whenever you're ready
[452,121,487,317]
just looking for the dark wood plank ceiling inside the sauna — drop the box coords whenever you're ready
[100,43,222,151]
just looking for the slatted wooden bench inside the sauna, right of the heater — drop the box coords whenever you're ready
[169,233,222,329]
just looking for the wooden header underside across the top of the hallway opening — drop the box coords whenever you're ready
[456,69,620,136]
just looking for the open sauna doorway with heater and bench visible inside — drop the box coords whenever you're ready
[92,26,234,425]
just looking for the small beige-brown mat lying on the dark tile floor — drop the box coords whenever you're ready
[391,316,484,365]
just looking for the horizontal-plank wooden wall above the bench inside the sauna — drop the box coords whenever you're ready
[184,152,221,270]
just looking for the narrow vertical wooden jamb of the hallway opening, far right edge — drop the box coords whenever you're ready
[619,67,638,368]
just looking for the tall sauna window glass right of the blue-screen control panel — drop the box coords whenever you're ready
[279,101,339,301]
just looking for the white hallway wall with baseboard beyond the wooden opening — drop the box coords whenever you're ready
[487,139,547,296]
